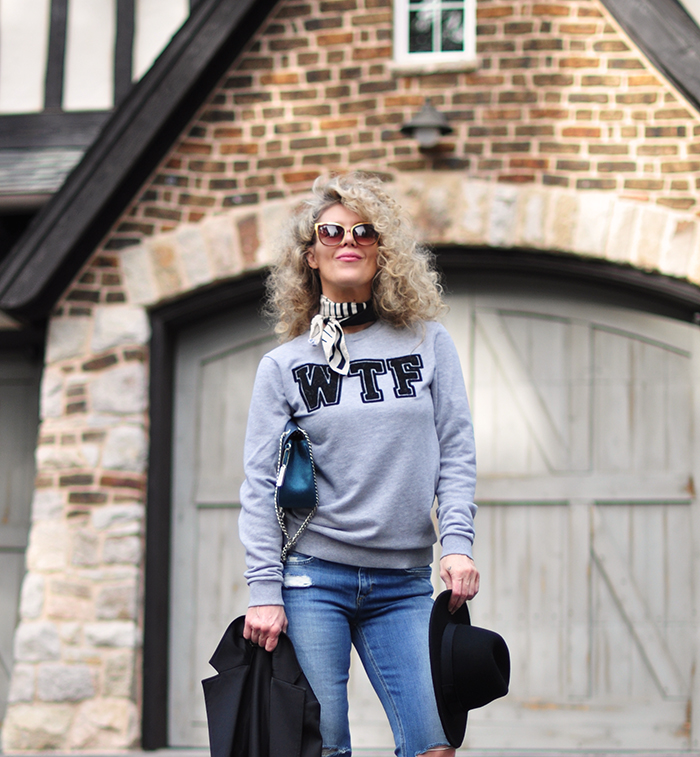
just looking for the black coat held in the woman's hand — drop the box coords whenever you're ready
[202,617,322,757]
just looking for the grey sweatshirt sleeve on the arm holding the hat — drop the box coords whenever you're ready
[432,326,477,557]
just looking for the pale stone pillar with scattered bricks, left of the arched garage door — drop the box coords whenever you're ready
[3,305,149,751]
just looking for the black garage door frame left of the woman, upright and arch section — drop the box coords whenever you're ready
[141,273,264,750]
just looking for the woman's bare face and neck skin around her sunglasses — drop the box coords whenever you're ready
[306,203,379,302]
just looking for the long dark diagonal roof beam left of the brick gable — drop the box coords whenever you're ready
[0,0,276,318]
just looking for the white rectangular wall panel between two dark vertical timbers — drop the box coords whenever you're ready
[63,0,117,110]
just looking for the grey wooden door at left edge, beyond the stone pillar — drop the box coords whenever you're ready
[0,354,39,720]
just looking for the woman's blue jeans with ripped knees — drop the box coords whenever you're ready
[283,552,448,757]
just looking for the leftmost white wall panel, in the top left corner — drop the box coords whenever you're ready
[0,0,50,113]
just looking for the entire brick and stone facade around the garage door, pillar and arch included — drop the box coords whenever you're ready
[3,0,700,751]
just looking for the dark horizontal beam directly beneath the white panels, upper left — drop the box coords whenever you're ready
[0,110,110,150]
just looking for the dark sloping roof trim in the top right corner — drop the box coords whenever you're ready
[602,0,700,110]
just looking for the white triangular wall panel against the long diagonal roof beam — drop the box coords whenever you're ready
[133,0,190,80]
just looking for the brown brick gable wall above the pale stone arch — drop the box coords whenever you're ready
[64,0,700,296]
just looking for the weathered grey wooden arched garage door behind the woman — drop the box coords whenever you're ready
[170,285,700,749]
